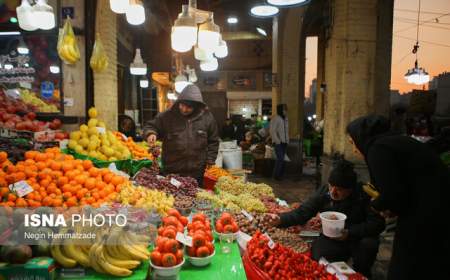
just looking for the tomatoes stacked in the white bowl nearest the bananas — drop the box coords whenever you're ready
[150,209,188,267]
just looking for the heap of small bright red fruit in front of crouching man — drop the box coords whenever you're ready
[247,231,337,280]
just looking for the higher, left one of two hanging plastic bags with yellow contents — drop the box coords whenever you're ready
[57,17,80,64]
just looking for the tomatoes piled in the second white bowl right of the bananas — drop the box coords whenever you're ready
[187,213,214,258]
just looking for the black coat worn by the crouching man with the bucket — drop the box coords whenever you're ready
[280,186,385,240]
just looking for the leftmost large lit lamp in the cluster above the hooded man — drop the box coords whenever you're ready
[171,5,197,52]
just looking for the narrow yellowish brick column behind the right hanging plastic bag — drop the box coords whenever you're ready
[94,0,118,130]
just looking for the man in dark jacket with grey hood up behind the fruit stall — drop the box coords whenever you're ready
[144,85,219,186]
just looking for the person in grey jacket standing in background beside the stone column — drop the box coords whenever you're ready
[270,104,289,180]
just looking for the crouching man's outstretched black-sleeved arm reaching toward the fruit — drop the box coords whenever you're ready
[279,186,328,227]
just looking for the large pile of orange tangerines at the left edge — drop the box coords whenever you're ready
[0,148,126,207]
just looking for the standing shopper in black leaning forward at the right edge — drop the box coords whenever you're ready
[347,115,450,280]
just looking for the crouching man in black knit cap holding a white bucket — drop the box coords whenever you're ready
[272,160,385,277]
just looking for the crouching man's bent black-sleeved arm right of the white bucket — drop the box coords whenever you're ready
[347,196,386,239]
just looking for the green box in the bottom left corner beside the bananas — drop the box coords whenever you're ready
[0,257,57,280]
